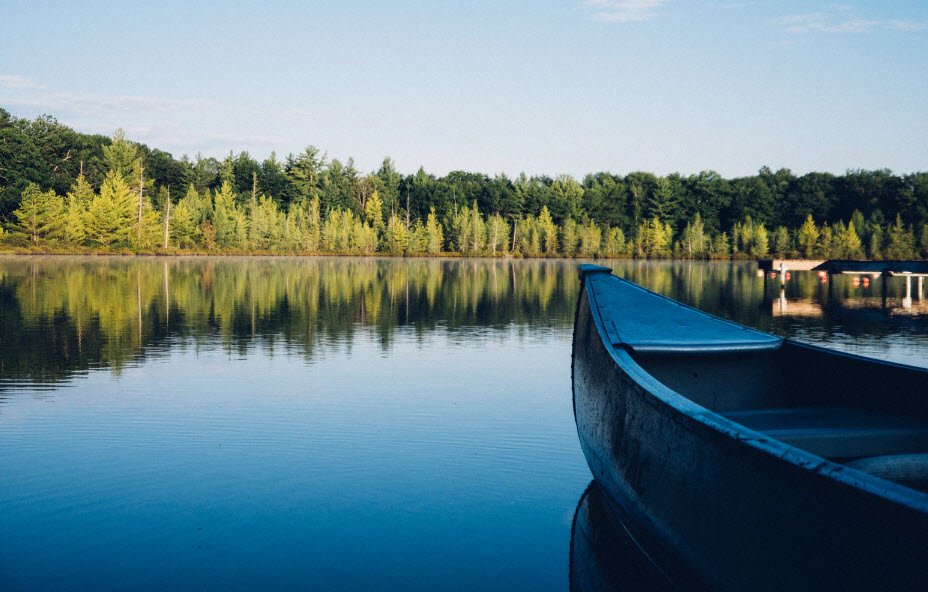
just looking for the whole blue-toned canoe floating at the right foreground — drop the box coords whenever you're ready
[571,265,928,590]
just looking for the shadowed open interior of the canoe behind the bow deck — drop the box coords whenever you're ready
[629,332,928,480]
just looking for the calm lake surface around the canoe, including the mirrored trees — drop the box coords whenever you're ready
[0,258,928,590]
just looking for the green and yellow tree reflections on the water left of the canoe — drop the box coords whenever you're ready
[0,257,579,382]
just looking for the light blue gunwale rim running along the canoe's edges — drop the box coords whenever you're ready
[574,268,928,512]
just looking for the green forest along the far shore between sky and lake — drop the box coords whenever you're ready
[0,109,928,259]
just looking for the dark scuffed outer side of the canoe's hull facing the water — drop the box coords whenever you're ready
[572,282,928,590]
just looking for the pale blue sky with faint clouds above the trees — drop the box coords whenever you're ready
[0,0,928,176]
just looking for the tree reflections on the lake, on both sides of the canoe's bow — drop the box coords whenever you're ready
[0,257,928,382]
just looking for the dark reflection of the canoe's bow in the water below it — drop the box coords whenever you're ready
[570,481,675,592]
